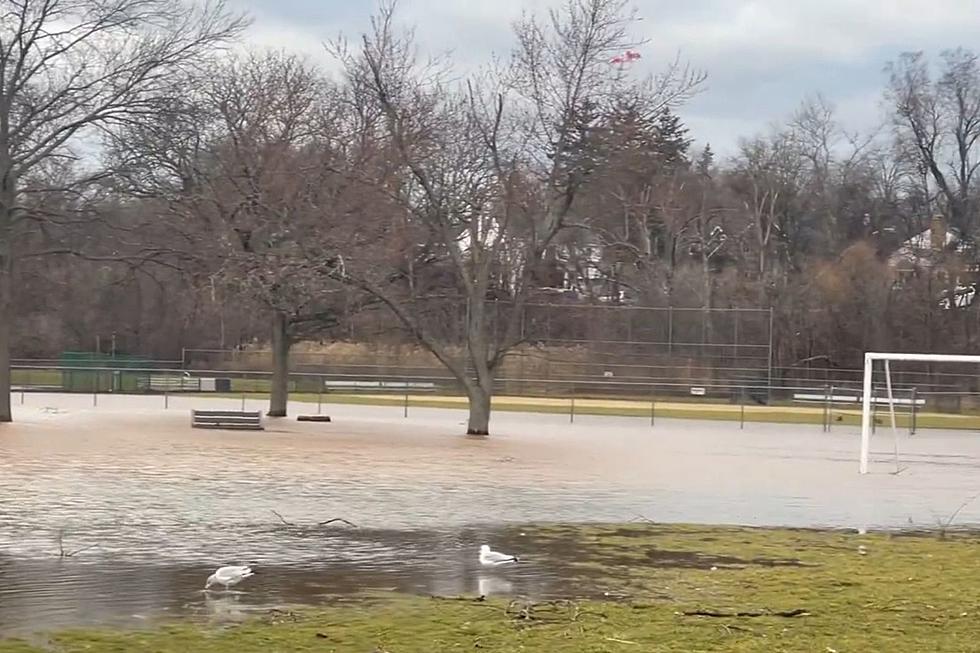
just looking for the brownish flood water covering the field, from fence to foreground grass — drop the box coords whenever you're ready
[0,395,980,635]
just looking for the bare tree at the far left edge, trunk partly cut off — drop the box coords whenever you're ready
[0,0,245,422]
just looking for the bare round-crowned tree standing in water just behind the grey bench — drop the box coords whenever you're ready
[106,53,376,417]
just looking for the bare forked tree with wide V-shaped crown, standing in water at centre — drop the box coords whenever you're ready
[334,0,700,435]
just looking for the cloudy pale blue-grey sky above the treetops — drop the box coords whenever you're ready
[228,0,980,154]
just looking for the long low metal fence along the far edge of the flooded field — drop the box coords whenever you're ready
[13,361,980,432]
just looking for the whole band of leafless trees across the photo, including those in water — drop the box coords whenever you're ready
[0,0,980,434]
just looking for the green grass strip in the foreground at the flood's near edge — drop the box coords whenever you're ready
[0,524,980,653]
